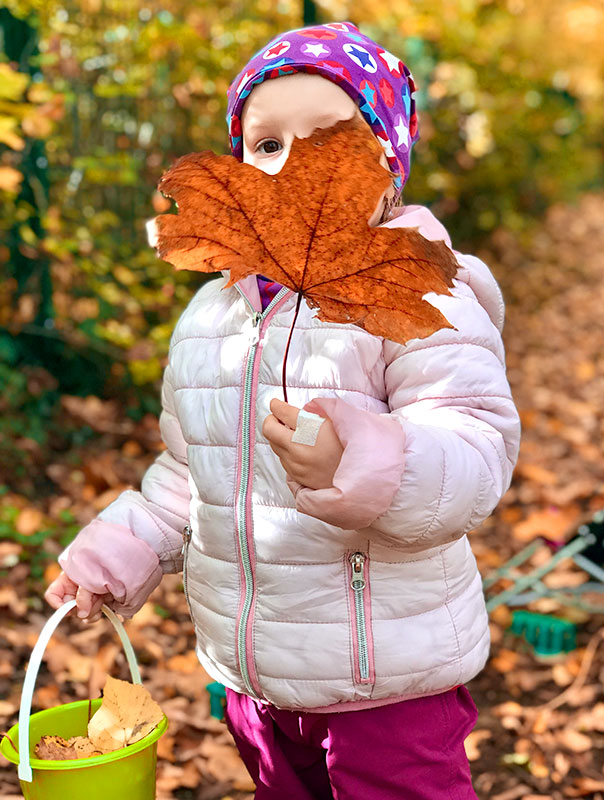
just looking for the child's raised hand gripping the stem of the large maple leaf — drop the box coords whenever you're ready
[262,398,344,489]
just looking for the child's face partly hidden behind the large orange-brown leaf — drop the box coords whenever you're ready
[241,72,391,226]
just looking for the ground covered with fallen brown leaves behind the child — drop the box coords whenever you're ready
[0,196,604,800]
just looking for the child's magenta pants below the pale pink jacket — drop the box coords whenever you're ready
[225,686,477,800]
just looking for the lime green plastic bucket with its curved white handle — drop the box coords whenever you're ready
[0,600,168,800]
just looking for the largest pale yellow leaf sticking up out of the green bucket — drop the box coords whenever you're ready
[88,676,164,753]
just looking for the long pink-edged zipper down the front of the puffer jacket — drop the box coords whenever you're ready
[236,286,291,699]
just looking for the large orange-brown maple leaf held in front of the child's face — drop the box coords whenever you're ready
[156,118,458,344]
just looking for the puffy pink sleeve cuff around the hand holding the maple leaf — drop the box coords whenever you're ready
[287,398,405,530]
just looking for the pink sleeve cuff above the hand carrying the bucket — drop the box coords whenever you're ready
[59,519,163,616]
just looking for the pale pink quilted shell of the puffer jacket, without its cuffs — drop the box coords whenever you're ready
[100,207,519,711]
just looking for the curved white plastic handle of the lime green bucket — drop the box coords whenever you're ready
[18,600,142,783]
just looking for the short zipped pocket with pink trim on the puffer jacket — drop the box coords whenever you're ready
[347,551,375,684]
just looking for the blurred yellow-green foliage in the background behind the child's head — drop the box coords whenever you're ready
[0,0,604,496]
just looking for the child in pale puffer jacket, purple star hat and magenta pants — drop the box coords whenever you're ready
[46,23,519,800]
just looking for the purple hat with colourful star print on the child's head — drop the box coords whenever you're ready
[227,22,419,194]
